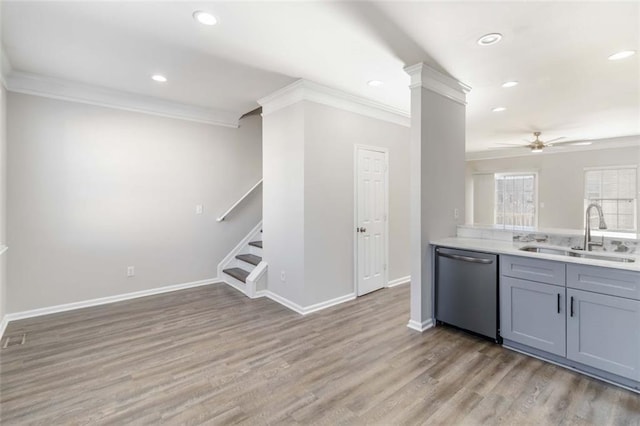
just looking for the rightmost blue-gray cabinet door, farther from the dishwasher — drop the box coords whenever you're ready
[567,289,640,380]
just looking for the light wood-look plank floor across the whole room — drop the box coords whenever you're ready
[0,284,640,425]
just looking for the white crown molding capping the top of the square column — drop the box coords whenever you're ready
[404,62,471,105]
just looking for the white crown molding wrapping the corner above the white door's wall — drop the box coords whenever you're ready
[258,79,411,127]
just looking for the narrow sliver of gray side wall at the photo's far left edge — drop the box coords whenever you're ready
[0,84,8,321]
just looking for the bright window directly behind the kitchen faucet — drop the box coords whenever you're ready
[584,166,638,232]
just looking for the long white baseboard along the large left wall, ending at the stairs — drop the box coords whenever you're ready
[3,277,222,322]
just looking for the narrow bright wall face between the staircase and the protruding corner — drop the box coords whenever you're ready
[262,103,305,306]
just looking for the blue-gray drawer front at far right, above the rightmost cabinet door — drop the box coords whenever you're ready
[567,264,640,300]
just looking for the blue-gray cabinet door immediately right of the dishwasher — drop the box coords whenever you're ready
[500,276,566,356]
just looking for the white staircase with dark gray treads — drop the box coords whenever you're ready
[218,228,267,298]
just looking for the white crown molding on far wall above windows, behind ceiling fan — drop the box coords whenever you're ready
[465,135,640,161]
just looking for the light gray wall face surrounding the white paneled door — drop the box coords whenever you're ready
[304,101,410,305]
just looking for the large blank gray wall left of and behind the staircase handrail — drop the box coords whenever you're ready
[7,93,262,313]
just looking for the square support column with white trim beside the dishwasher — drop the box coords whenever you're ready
[405,63,470,331]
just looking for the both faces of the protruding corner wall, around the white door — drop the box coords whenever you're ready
[263,101,410,307]
